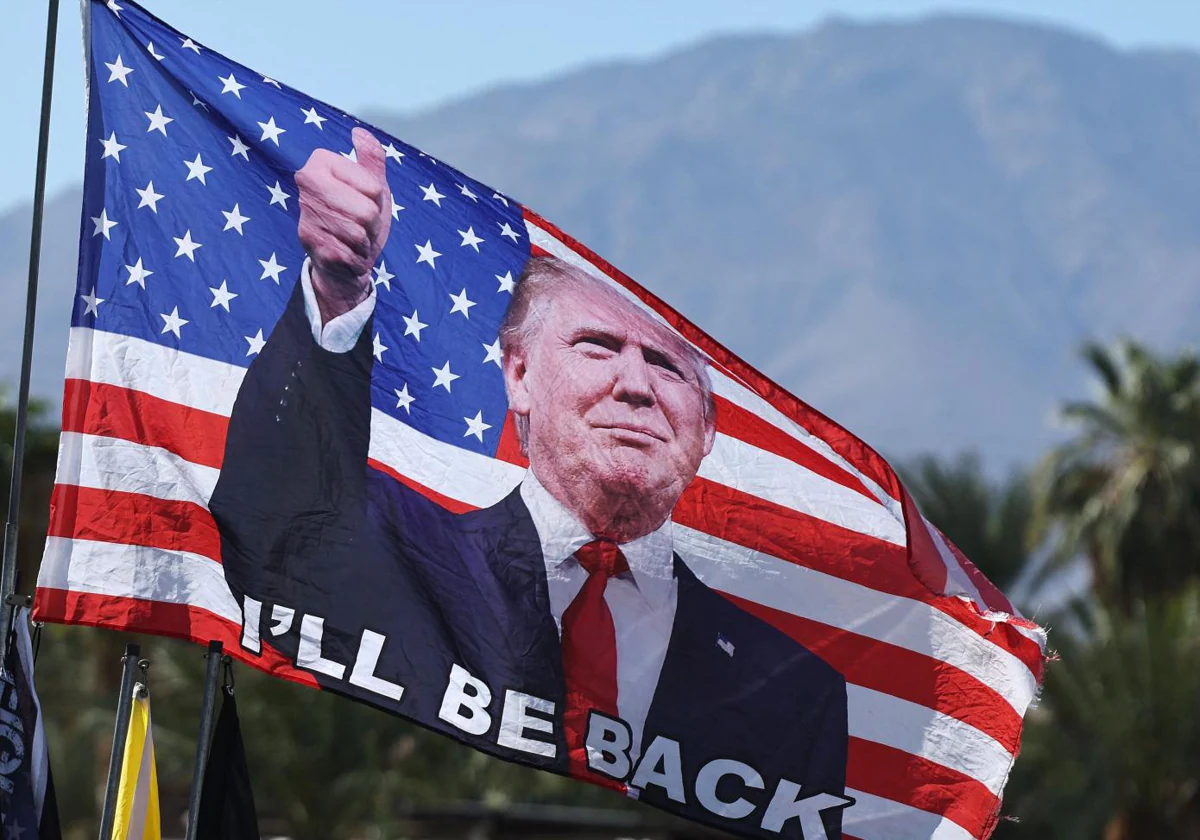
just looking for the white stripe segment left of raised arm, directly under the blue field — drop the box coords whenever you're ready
[66,326,246,416]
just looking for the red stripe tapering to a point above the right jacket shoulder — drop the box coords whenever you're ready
[725,594,1021,752]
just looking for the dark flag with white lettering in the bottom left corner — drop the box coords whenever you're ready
[0,607,62,840]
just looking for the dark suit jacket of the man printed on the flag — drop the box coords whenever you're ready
[210,284,847,838]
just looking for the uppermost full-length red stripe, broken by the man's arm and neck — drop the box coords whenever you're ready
[65,380,1042,674]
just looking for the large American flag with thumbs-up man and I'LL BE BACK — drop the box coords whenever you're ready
[35,0,1045,840]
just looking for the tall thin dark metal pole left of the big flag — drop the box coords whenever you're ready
[0,0,59,650]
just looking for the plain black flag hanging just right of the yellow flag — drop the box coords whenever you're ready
[196,686,258,840]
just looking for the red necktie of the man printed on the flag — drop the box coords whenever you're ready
[563,540,629,791]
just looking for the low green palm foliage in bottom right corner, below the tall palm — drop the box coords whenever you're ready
[996,586,1200,840]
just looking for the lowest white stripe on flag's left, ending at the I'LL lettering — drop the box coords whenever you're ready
[37,536,241,626]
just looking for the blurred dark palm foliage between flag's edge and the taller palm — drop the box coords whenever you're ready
[899,454,1033,592]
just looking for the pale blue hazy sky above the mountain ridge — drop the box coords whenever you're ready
[7,0,1200,211]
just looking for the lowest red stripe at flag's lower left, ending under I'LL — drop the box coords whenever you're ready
[34,587,317,688]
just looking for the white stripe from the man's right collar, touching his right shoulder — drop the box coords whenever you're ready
[672,522,1037,714]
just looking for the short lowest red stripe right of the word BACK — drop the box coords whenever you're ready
[846,738,1000,838]
